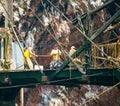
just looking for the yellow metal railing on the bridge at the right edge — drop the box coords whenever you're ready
[92,42,120,68]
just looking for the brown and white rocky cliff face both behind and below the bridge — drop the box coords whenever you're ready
[14,0,120,106]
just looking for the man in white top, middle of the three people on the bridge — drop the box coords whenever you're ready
[50,45,62,69]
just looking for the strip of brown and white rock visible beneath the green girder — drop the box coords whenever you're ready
[23,85,120,106]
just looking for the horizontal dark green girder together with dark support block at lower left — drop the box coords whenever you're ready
[0,68,120,106]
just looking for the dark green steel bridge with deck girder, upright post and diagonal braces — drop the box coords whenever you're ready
[0,0,120,106]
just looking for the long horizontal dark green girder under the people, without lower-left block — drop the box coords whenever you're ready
[0,68,120,89]
